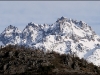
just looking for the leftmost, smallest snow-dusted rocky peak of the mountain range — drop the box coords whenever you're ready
[0,25,21,45]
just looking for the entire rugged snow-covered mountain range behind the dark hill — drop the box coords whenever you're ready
[0,17,100,66]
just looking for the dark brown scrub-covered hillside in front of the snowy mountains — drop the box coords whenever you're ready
[0,45,100,75]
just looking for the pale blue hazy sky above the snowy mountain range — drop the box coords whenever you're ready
[0,1,100,35]
